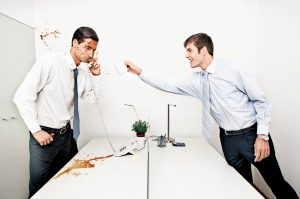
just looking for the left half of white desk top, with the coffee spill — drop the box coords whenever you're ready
[32,139,147,199]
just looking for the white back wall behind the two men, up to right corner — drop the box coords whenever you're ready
[32,0,258,150]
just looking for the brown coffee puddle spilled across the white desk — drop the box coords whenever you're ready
[54,155,113,179]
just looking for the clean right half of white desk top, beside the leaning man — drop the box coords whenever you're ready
[149,138,263,199]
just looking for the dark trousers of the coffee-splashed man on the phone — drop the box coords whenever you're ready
[29,129,78,198]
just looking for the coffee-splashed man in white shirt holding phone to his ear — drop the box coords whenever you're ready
[14,27,100,197]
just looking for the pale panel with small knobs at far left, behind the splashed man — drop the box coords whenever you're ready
[0,14,35,199]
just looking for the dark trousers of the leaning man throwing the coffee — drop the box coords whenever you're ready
[220,127,299,199]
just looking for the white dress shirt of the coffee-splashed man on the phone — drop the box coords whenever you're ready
[14,52,98,133]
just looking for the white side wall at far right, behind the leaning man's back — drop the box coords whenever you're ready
[258,0,300,195]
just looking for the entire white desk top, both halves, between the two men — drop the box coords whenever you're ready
[32,138,263,199]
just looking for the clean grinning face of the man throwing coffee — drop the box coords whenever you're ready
[185,43,204,68]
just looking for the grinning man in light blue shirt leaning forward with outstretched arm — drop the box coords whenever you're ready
[125,33,298,198]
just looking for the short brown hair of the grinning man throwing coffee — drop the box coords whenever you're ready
[184,33,214,56]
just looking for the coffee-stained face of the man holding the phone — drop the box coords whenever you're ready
[73,38,98,63]
